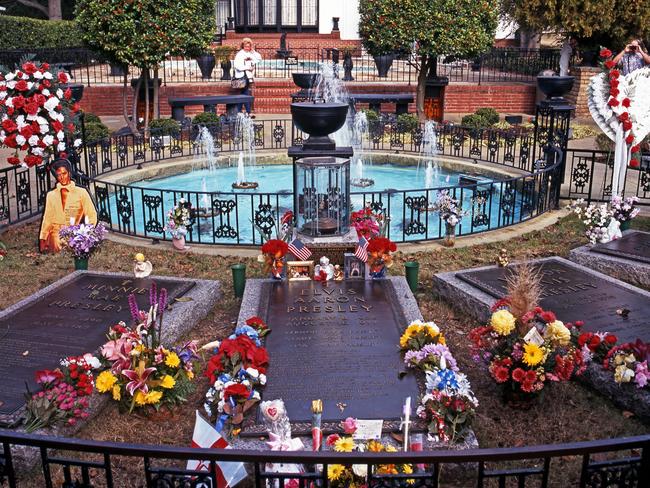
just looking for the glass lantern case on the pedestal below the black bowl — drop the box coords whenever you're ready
[293,156,350,237]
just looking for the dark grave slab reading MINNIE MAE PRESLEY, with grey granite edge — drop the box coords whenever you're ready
[0,272,219,425]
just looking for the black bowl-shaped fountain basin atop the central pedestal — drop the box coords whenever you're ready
[291,102,348,137]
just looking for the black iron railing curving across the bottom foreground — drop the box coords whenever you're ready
[0,430,650,488]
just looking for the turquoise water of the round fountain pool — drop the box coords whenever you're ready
[109,163,522,244]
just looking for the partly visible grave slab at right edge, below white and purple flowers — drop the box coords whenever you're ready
[569,230,650,288]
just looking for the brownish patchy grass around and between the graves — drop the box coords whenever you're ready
[0,217,650,486]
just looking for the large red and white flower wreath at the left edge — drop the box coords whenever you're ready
[0,62,81,167]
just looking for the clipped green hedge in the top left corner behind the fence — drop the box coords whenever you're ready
[0,15,83,49]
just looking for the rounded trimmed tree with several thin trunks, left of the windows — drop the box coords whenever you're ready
[76,0,216,132]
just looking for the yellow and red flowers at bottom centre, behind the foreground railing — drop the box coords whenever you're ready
[325,434,413,488]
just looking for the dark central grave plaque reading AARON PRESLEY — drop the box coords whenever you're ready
[258,281,418,422]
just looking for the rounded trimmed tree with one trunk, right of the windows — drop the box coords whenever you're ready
[359,0,499,118]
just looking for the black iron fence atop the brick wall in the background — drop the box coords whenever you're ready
[0,46,559,86]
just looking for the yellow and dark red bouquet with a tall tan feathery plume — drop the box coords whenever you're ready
[469,264,586,409]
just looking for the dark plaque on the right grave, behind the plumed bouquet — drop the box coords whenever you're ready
[456,259,650,342]
